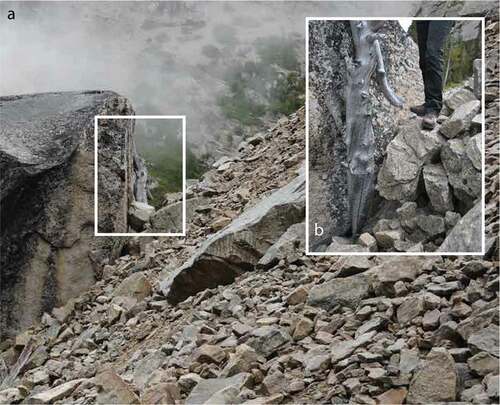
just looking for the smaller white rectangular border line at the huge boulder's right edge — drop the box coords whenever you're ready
[94,115,186,236]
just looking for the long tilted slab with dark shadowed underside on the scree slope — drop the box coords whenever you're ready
[160,170,305,303]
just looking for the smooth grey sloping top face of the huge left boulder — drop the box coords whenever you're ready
[0,91,115,199]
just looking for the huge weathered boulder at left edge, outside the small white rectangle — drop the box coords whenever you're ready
[0,91,133,334]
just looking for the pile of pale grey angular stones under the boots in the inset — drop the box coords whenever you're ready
[328,79,483,252]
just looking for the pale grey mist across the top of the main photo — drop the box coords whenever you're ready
[0,2,418,150]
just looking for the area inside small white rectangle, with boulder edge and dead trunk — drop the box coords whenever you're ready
[95,115,186,236]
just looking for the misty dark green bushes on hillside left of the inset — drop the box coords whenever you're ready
[217,37,305,126]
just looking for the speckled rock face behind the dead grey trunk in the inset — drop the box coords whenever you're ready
[309,21,421,246]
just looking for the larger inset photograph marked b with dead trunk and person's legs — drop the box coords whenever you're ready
[306,18,484,255]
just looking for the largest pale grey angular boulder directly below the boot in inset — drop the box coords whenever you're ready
[377,121,445,201]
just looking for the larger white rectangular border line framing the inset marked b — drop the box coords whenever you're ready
[305,17,486,256]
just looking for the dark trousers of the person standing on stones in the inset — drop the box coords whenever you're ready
[425,20,453,114]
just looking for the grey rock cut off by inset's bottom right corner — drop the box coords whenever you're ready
[438,201,482,253]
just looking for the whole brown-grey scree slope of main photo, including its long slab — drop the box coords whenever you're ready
[0,15,499,404]
